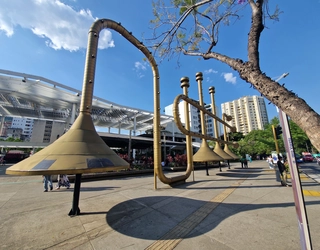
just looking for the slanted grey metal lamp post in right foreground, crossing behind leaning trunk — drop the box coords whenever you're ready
[276,73,312,250]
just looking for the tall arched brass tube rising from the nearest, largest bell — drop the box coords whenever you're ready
[80,19,190,189]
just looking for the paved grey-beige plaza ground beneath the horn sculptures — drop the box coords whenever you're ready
[0,161,320,250]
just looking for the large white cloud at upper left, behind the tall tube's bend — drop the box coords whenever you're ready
[0,0,115,51]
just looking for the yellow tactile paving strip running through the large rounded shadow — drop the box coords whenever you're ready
[146,179,245,250]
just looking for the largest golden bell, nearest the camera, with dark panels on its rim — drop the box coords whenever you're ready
[6,113,129,175]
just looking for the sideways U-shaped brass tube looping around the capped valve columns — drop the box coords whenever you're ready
[173,94,236,145]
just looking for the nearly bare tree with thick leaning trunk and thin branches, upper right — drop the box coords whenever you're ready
[151,0,320,150]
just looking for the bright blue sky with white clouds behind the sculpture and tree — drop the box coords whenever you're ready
[0,0,320,120]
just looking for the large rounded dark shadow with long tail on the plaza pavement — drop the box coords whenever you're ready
[106,196,320,240]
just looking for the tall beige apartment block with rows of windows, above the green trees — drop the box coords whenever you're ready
[221,96,269,135]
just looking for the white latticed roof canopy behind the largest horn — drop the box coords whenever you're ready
[0,69,173,131]
